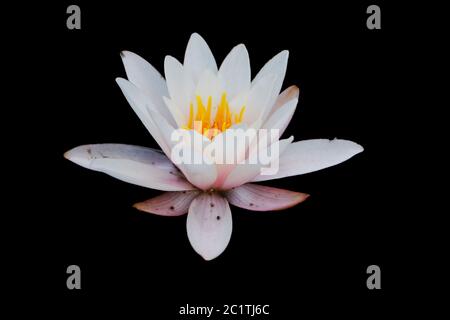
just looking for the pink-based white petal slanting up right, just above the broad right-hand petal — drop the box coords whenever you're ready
[220,137,294,190]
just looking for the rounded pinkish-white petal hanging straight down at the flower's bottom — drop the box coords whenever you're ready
[186,192,233,260]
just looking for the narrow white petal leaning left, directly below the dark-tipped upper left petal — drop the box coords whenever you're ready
[116,78,170,155]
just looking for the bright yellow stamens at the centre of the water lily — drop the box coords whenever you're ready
[183,93,245,140]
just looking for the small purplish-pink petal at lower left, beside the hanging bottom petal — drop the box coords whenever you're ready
[133,190,200,216]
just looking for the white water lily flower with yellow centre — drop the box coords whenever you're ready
[65,33,363,260]
